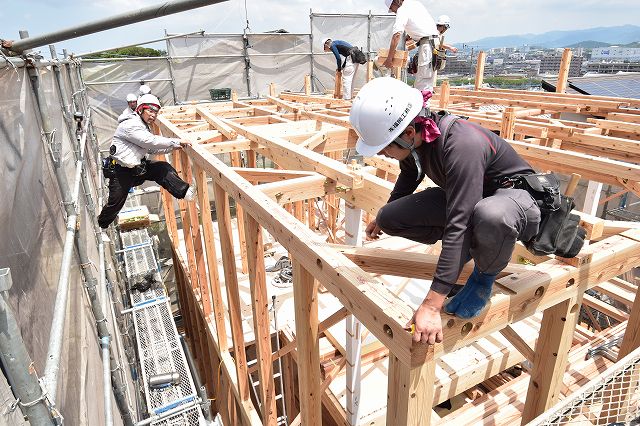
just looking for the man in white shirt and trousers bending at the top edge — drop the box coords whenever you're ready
[383,0,438,91]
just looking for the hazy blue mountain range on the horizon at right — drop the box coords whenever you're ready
[457,25,640,49]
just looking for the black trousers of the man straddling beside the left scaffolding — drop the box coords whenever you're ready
[98,161,189,228]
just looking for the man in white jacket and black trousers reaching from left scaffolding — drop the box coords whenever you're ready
[98,95,195,228]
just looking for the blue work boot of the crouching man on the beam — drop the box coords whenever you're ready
[444,267,498,319]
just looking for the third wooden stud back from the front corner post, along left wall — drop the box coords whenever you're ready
[214,183,249,401]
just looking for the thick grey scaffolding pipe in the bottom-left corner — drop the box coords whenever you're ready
[0,268,55,426]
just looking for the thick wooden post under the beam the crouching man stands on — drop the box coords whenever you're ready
[522,294,582,424]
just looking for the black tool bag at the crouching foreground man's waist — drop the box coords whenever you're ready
[501,173,587,257]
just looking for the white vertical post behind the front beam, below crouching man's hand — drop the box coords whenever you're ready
[344,202,362,425]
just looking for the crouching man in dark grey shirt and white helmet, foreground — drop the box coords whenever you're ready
[350,77,540,344]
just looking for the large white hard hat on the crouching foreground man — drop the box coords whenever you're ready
[349,77,424,157]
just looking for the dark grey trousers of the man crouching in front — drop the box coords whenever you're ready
[376,188,540,274]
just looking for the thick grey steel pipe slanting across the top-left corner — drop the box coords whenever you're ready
[8,0,226,53]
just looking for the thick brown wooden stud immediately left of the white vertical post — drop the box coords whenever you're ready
[292,258,322,426]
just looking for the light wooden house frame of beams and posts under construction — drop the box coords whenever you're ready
[156,71,640,425]
